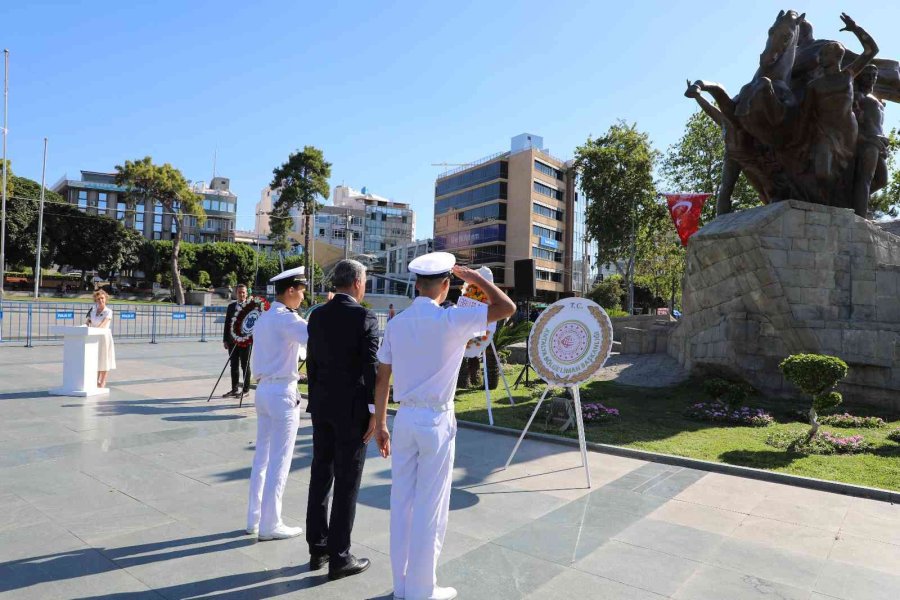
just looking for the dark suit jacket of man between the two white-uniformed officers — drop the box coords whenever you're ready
[306,294,378,422]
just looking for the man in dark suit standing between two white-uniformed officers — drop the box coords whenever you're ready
[306,260,378,579]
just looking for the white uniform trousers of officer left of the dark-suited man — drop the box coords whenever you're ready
[247,381,300,535]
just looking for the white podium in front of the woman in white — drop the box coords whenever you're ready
[50,325,109,396]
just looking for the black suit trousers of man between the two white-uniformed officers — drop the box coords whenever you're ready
[306,411,369,568]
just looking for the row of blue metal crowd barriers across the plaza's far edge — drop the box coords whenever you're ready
[0,300,387,346]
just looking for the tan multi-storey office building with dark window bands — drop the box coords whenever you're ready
[434,133,596,301]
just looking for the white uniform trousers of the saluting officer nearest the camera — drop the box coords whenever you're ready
[391,404,456,600]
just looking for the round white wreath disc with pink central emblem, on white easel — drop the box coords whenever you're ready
[528,298,613,386]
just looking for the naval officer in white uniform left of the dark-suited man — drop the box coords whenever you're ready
[247,267,308,541]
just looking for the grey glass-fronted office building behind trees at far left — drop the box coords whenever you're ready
[51,171,237,242]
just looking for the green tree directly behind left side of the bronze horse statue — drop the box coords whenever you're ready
[660,111,761,227]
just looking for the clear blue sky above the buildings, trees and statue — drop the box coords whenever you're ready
[0,0,900,238]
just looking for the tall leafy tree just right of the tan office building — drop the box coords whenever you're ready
[575,121,659,314]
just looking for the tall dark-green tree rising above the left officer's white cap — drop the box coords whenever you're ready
[269,146,331,290]
